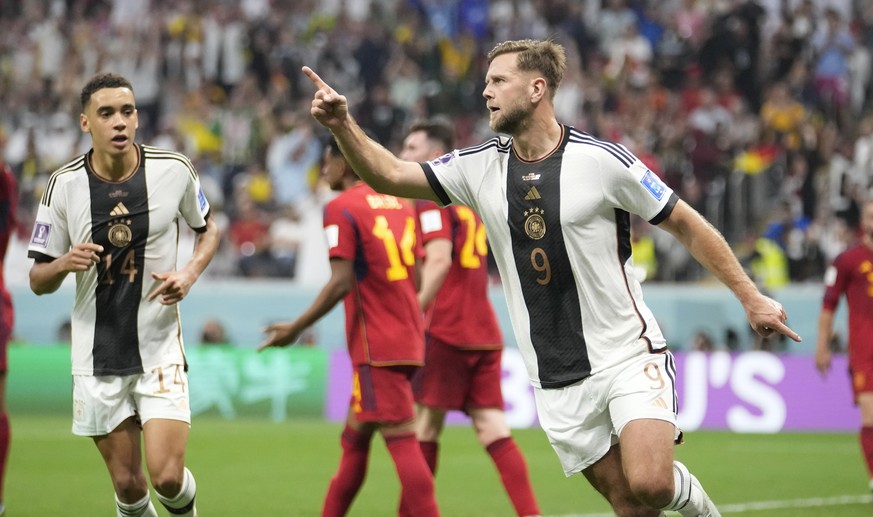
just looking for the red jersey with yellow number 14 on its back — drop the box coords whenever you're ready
[324,182,424,366]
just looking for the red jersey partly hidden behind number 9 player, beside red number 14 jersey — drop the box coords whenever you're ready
[415,201,503,349]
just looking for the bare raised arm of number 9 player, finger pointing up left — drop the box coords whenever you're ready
[303,66,438,201]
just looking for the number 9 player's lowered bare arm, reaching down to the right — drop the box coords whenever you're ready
[660,201,800,341]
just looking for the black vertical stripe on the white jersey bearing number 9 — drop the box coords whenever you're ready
[506,134,591,388]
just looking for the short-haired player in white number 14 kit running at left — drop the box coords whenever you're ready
[28,74,221,517]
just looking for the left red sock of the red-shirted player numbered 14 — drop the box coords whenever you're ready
[321,426,372,517]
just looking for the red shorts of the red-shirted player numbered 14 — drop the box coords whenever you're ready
[349,365,419,424]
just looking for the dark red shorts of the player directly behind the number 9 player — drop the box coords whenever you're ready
[415,336,503,411]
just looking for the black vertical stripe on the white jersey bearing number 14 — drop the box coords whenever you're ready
[88,160,149,375]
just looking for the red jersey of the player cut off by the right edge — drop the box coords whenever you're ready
[823,245,873,369]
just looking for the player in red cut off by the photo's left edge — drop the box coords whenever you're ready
[0,132,18,515]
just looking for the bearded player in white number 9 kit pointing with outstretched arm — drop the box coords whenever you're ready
[303,40,800,516]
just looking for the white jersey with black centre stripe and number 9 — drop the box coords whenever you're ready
[422,126,678,388]
